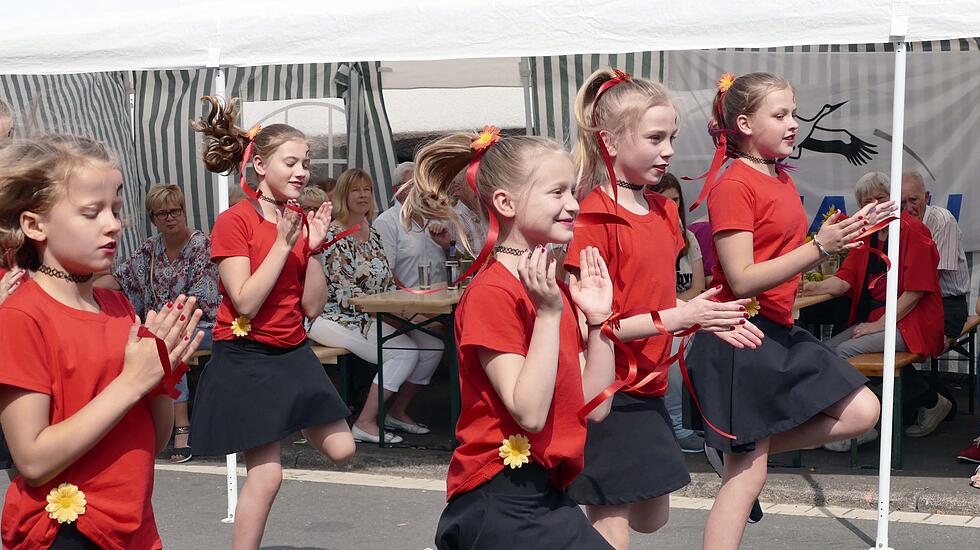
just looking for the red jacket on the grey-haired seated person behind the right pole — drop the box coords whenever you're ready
[836,214,944,357]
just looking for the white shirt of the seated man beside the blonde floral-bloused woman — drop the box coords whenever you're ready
[372,202,446,288]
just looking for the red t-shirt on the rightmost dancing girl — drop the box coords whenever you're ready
[708,160,807,327]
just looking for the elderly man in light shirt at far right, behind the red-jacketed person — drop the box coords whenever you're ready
[902,170,970,346]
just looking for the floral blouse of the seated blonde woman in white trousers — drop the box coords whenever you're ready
[320,224,395,336]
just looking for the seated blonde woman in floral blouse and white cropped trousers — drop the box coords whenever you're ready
[309,168,443,443]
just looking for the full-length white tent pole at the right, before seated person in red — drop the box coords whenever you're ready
[874,33,907,550]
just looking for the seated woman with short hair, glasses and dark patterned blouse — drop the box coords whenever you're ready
[96,184,220,463]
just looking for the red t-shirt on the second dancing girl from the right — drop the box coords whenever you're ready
[565,189,684,397]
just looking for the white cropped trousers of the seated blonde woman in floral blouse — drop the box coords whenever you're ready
[309,317,444,392]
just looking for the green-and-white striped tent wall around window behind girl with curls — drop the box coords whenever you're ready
[134,63,395,237]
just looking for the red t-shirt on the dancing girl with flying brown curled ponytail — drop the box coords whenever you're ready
[211,201,309,348]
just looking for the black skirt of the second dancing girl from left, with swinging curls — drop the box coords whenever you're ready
[190,339,350,456]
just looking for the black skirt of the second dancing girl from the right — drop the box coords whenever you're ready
[568,392,691,505]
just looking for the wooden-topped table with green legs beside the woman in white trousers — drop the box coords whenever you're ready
[350,288,463,448]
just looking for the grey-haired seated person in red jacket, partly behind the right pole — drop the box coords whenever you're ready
[803,172,952,451]
